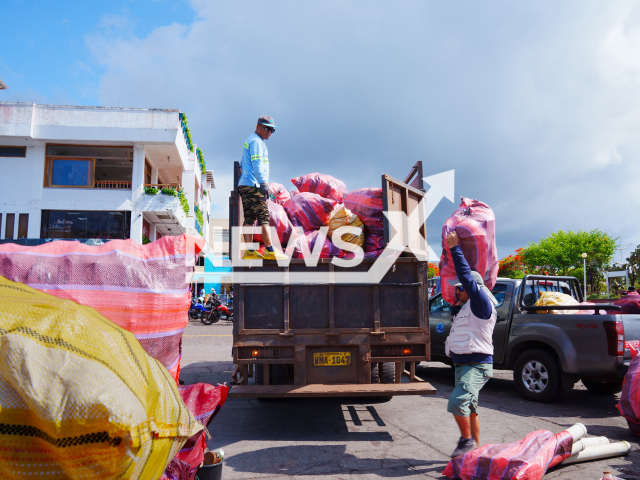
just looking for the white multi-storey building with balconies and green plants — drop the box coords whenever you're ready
[0,102,215,244]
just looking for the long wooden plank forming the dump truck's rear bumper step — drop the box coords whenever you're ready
[229,382,438,398]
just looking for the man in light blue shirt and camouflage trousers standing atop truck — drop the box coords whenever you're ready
[238,115,287,260]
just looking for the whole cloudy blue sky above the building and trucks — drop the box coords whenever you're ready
[0,0,640,257]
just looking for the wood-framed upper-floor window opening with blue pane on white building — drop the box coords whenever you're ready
[44,145,133,189]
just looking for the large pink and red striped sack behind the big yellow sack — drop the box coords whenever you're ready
[0,235,200,381]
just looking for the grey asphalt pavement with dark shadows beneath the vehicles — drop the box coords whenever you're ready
[181,323,640,480]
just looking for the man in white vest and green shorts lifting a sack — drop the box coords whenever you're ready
[445,231,498,457]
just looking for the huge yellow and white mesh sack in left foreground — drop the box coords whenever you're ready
[0,277,203,480]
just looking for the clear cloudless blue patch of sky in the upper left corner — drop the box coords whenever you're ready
[0,0,195,105]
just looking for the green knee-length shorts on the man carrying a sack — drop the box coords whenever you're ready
[447,363,493,417]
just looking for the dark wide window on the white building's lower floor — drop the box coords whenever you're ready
[40,210,131,239]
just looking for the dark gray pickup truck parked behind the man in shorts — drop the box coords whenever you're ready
[429,275,640,402]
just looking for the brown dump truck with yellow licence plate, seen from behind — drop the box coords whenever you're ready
[229,162,436,399]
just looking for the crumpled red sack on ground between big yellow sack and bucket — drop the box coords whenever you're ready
[160,383,229,480]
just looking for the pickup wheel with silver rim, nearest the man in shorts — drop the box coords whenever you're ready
[513,349,563,403]
